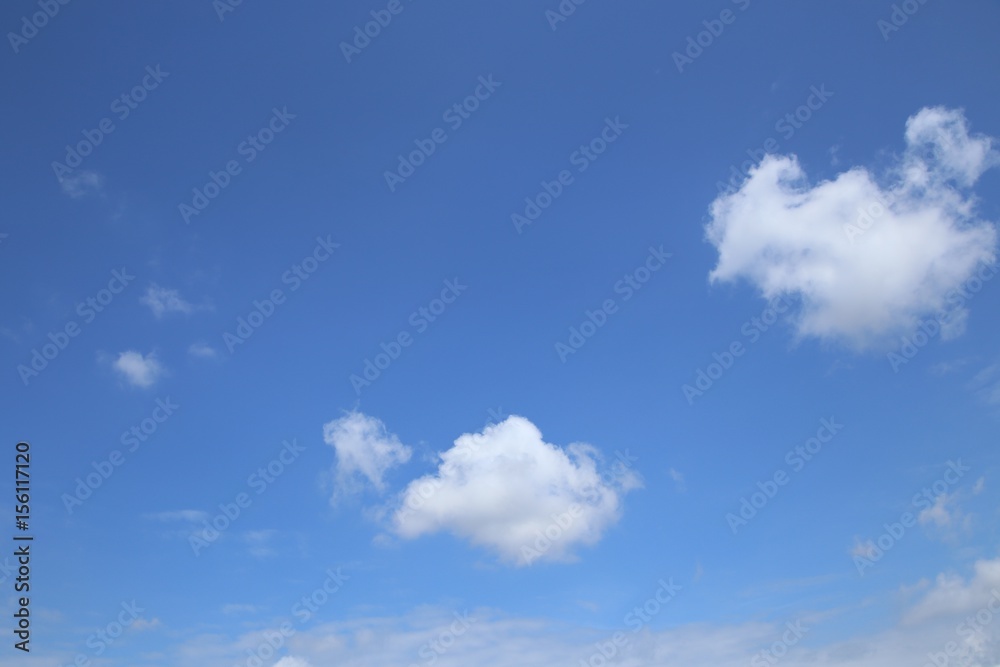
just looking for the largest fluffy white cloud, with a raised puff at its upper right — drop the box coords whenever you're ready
[706,108,1000,348]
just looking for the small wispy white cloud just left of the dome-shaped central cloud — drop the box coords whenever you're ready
[323,411,412,500]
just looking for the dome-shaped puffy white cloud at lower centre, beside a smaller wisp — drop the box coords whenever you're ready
[392,416,640,565]
